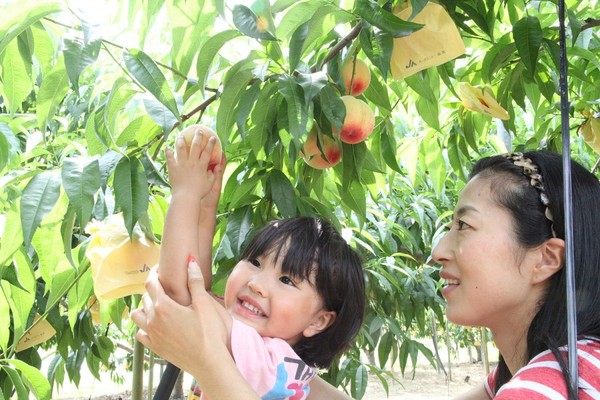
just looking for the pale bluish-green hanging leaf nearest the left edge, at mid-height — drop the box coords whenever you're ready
[21,171,61,247]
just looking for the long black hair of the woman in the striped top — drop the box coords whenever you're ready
[470,151,600,398]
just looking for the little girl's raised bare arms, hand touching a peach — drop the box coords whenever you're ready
[158,133,222,305]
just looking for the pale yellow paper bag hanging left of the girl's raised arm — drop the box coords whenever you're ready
[85,214,159,300]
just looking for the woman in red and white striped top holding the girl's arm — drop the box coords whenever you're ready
[134,151,600,400]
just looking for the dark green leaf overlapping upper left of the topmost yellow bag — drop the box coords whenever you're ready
[354,0,423,37]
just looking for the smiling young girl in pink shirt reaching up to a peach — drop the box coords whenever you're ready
[158,133,365,399]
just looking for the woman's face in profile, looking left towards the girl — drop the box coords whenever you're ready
[432,176,539,332]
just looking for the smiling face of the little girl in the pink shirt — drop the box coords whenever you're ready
[224,248,335,345]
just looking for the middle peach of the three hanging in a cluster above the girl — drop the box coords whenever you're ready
[334,96,375,144]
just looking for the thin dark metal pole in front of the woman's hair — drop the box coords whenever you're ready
[558,0,579,400]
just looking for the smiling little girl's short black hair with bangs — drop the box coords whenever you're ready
[242,217,365,368]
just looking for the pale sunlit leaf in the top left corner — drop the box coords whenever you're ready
[0,0,64,54]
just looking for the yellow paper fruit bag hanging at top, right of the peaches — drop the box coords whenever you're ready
[390,2,466,79]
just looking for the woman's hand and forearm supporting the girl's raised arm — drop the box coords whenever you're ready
[131,262,252,400]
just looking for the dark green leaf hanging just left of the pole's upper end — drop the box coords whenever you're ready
[513,15,544,76]
